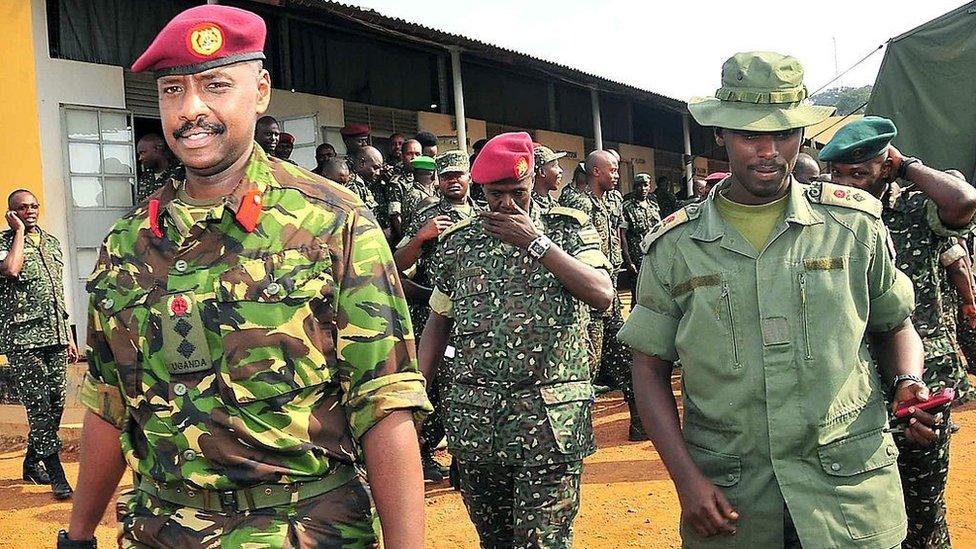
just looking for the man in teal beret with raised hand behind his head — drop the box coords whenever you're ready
[820,116,976,548]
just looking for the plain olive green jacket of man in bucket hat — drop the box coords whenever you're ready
[620,181,912,548]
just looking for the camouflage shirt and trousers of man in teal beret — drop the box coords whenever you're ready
[882,184,973,547]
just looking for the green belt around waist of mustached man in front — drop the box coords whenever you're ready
[134,464,359,512]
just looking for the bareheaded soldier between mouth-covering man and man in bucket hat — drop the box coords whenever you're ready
[559,151,647,441]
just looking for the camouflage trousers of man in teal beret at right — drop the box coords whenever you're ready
[895,404,952,549]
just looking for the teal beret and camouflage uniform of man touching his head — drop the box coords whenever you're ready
[821,116,976,548]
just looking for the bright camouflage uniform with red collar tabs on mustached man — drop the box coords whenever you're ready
[81,145,431,547]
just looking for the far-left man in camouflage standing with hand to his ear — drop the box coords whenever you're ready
[0,189,78,499]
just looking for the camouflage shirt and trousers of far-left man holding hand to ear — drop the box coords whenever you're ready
[0,228,71,459]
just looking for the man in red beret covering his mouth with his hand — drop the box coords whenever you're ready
[420,133,613,548]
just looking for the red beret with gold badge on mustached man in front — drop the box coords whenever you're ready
[132,5,267,78]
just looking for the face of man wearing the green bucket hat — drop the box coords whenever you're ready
[715,128,803,199]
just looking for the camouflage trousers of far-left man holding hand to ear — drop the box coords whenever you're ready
[7,345,68,457]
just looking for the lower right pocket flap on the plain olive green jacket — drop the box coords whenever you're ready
[817,429,898,477]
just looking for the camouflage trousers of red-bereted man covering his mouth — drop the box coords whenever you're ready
[458,460,583,549]
